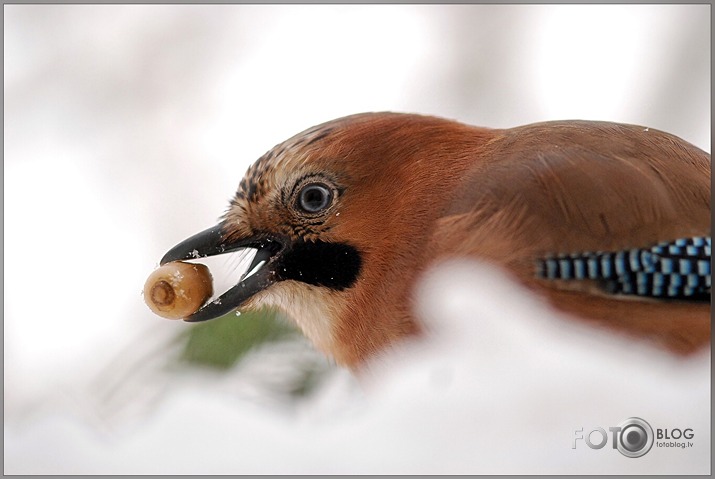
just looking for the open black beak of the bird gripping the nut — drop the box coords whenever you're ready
[160,223,284,322]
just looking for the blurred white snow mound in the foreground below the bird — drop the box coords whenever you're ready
[5,261,711,474]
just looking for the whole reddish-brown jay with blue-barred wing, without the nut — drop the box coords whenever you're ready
[160,112,711,371]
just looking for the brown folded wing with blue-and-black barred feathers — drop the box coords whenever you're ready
[431,121,711,352]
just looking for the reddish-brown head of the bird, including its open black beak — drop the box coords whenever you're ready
[161,113,492,366]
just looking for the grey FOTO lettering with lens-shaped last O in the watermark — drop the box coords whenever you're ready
[572,417,660,457]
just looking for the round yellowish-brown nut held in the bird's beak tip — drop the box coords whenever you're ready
[144,261,213,319]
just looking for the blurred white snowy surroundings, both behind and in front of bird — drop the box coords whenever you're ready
[3,5,711,474]
